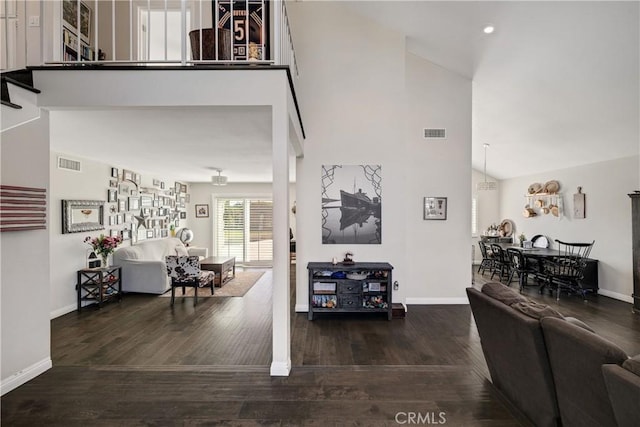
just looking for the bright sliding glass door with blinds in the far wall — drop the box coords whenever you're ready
[216,198,273,265]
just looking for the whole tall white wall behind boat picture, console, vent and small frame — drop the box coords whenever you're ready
[288,2,471,311]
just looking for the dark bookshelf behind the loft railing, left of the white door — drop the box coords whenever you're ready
[62,0,96,61]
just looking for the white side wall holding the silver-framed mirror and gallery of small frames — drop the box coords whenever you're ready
[49,152,189,318]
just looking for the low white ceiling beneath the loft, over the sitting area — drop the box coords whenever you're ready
[51,106,280,182]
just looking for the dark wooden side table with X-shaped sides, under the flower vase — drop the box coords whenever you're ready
[76,267,122,311]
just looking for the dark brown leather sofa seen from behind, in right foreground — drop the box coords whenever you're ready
[467,283,640,427]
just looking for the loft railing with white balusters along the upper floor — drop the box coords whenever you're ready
[0,0,297,75]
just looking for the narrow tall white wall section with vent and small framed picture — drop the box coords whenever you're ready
[408,54,471,304]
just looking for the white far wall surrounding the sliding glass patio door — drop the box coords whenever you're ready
[187,182,296,256]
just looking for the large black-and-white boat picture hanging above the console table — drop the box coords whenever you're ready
[322,165,382,245]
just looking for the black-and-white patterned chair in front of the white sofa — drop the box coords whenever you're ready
[165,255,215,305]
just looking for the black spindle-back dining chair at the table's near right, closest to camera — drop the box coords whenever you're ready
[543,239,595,300]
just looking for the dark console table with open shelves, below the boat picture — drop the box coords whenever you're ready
[307,262,393,320]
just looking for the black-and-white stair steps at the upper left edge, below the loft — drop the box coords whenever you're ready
[1,69,40,131]
